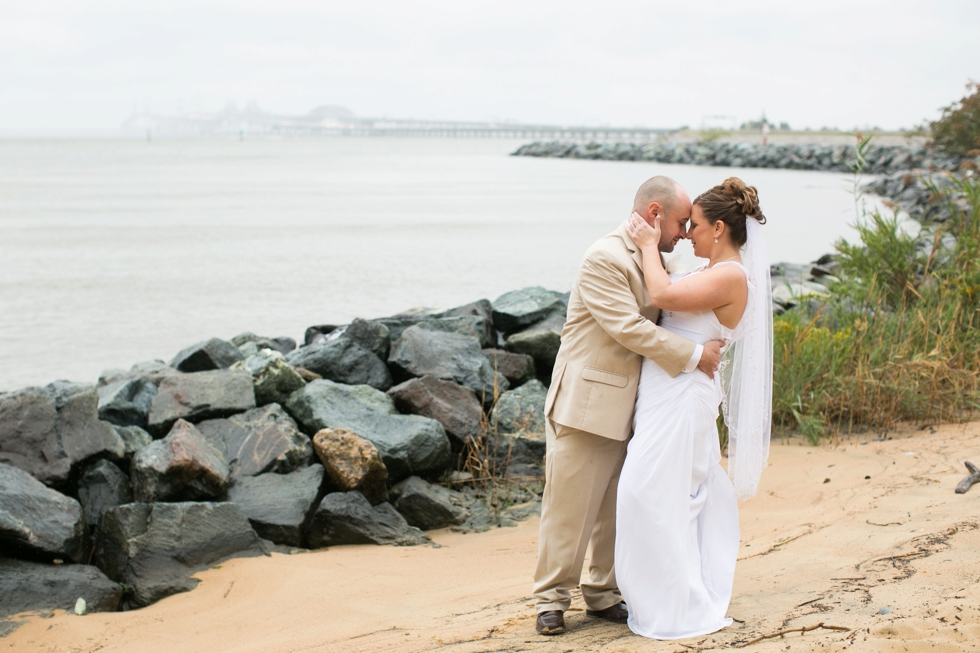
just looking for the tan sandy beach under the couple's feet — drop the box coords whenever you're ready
[0,422,980,653]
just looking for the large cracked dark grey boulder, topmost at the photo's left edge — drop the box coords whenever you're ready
[0,381,125,487]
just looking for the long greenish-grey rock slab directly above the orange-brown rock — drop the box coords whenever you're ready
[286,379,451,482]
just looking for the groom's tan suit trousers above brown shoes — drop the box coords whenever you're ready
[534,419,627,612]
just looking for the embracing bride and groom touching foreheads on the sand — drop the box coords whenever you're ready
[534,177,772,639]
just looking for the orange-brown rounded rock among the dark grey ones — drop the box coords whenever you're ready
[313,429,388,505]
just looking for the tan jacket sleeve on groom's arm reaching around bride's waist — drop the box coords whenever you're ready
[579,247,696,376]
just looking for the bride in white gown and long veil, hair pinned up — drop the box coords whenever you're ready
[615,177,772,639]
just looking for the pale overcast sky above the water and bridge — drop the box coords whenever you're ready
[0,0,980,133]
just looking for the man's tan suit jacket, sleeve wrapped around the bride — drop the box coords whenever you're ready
[544,224,696,440]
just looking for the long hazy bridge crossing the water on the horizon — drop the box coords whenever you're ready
[123,105,678,142]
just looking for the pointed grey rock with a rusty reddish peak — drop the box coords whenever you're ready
[132,420,230,502]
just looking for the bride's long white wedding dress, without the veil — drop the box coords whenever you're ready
[615,262,745,639]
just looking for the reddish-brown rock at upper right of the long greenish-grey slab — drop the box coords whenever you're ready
[388,376,483,444]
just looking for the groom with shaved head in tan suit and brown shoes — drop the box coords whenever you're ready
[534,177,722,635]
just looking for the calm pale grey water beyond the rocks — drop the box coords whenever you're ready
[0,139,872,390]
